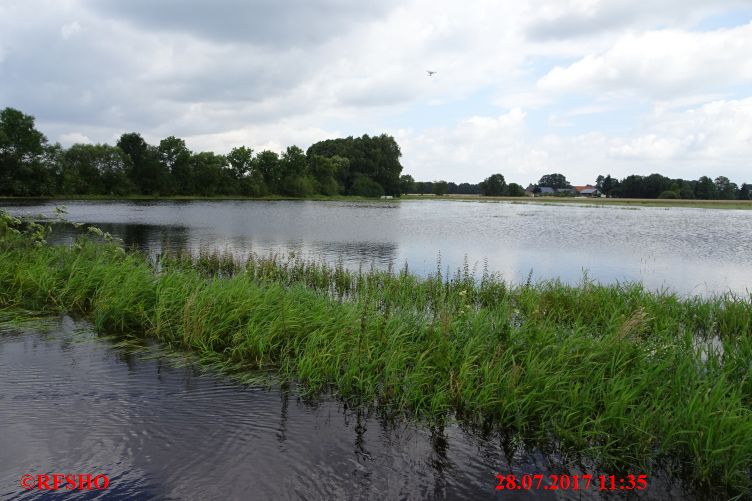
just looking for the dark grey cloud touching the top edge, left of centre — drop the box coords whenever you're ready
[88,0,398,46]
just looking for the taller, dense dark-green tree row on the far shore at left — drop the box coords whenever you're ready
[0,108,402,197]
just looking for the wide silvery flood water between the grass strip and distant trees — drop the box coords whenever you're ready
[0,200,752,295]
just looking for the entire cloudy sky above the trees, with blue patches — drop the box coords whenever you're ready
[0,0,752,186]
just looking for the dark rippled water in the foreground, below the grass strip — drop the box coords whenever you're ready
[0,317,688,500]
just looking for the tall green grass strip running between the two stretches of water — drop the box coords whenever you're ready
[0,220,752,493]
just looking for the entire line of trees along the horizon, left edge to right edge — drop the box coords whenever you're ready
[0,108,752,200]
